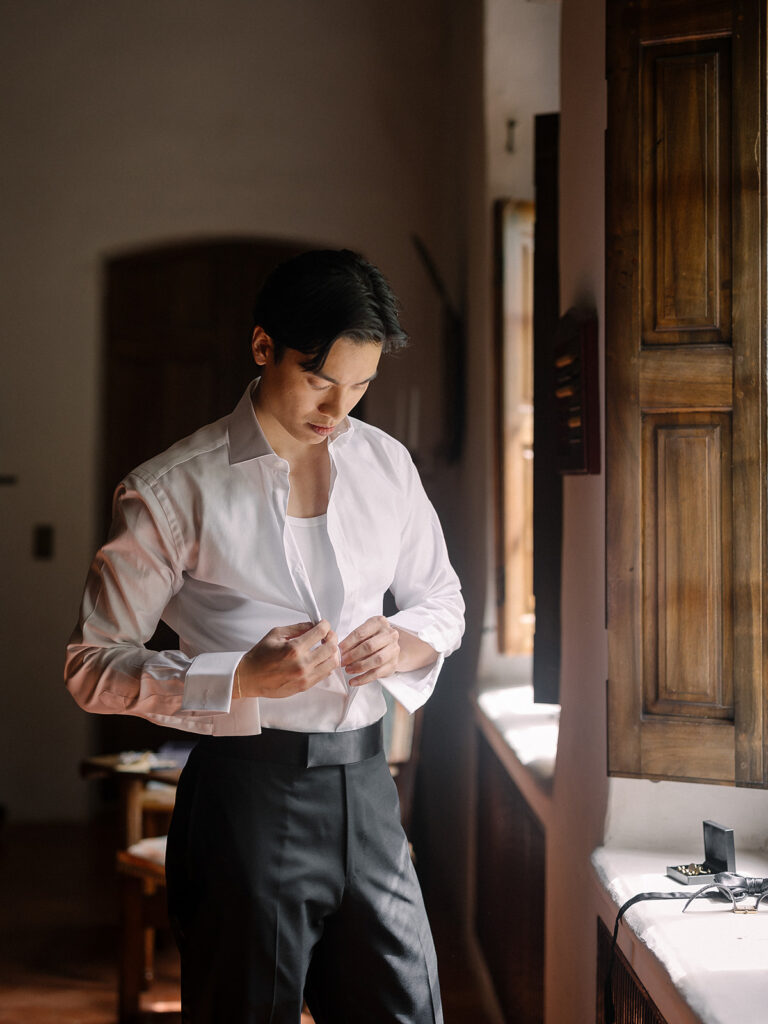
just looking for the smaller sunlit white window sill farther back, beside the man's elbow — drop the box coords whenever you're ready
[472,679,560,827]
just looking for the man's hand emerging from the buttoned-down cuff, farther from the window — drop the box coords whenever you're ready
[232,618,339,697]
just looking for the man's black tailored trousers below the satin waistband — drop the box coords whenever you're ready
[166,737,442,1024]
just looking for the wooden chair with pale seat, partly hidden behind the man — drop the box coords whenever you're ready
[117,694,422,1024]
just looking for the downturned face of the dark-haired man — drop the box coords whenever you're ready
[253,328,382,454]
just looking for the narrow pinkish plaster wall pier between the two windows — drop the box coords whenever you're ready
[545,0,608,1024]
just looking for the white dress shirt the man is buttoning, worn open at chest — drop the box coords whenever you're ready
[65,384,464,735]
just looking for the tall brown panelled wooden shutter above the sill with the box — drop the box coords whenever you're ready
[605,0,766,785]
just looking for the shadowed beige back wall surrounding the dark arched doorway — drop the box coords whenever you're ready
[0,0,458,818]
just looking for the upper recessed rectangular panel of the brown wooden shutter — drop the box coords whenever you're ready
[640,38,731,345]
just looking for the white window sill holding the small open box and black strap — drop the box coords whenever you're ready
[592,847,768,1024]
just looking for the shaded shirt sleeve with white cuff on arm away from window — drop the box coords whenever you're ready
[65,476,244,731]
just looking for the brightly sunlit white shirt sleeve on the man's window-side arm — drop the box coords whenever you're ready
[381,457,464,712]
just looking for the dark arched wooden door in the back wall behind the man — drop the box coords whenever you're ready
[99,241,311,751]
